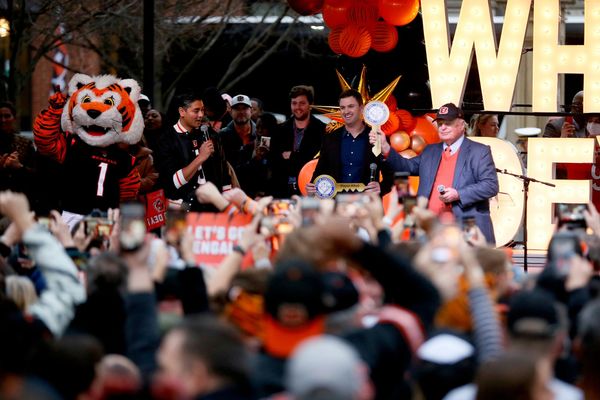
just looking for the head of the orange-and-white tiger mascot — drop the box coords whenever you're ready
[61,74,144,147]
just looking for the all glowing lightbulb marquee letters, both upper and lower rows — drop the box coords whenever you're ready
[421,0,600,249]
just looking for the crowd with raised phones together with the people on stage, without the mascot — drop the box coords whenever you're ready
[0,85,600,400]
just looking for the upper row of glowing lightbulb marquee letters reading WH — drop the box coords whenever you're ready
[421,0,600,113]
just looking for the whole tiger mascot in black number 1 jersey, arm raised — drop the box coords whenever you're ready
[33,74,144,226]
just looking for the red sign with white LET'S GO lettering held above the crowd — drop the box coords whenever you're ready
[187,212,252,267]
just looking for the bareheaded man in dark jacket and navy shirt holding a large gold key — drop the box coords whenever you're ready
[306,89,393,195]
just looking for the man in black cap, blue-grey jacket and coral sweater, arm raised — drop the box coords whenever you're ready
[369,103,498,245]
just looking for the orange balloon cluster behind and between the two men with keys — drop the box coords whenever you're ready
[381,95,440,158]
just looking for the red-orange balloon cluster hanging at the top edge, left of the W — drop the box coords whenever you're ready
[288,0,420,57]
